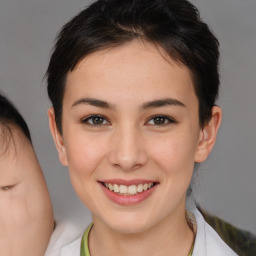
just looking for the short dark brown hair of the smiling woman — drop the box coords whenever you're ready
[46,0,219,132]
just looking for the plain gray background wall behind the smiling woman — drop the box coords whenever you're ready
[0,0,256,233]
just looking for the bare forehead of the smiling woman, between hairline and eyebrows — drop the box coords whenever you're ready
[64,41,195,107]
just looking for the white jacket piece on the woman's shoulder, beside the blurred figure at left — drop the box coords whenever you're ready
[45,223,83,256]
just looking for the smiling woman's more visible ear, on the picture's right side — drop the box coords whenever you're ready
[194,106,222,163]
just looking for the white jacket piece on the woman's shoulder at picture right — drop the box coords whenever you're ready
[192,209,237,256]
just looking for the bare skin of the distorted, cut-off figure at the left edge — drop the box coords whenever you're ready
[0,124,54,256]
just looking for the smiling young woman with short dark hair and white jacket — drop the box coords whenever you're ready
[47,0,238,256]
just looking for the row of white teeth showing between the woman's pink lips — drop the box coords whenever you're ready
[101,182,158,196]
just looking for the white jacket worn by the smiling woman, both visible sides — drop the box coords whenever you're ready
[45,209,237,256]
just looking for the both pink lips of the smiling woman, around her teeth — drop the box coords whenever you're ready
[99,179,157,206]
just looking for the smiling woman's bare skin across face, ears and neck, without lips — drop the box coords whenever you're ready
[48,41,221,256]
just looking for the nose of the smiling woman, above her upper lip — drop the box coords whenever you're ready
[109,126,148,171]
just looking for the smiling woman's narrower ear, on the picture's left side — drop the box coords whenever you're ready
[48,108,68,166]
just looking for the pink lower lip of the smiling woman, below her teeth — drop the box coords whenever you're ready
[100,183,157,206]
